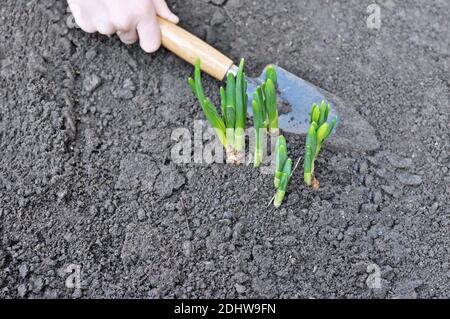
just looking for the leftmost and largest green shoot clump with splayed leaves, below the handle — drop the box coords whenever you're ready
[188,59,247,162]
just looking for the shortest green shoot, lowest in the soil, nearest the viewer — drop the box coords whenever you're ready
[273,135,292,208]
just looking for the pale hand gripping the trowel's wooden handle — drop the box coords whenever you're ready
[67,0,178,52]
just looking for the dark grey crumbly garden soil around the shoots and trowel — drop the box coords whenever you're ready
[0,0,450,298]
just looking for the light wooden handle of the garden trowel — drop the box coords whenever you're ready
[158,17,233,81]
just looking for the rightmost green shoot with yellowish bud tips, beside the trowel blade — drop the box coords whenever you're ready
[303,101,336,189]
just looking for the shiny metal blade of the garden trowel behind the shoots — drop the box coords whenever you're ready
[247,66,379,151]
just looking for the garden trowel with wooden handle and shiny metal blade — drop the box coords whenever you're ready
[158,18,379,151]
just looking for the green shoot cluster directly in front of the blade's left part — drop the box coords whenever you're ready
[252,66,278,167]
